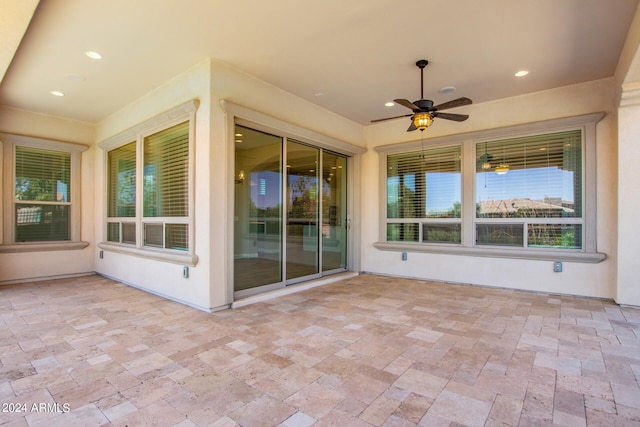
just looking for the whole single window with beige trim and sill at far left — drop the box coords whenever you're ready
[0,134,86,252]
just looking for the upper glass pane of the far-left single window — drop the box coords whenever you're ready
[15,146,71,202]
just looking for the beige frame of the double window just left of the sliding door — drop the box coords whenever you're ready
[98,100,198,266]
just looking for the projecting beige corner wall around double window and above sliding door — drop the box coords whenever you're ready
[93,60,364,310]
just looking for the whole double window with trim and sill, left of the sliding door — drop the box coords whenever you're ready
[99,102,197,263]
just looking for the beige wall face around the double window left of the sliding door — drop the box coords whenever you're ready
[91,61,212,310]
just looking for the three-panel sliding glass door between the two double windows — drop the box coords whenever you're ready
[234,125,348,298]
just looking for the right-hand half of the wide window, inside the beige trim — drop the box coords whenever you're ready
[475,129,583,249]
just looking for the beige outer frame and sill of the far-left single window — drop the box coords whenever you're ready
[0,133,89,253]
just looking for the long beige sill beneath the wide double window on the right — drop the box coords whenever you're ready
[373,242,607,264]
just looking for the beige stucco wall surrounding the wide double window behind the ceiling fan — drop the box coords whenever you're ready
[362,79,616,298]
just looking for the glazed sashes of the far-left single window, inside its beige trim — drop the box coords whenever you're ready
[14,146,71,242]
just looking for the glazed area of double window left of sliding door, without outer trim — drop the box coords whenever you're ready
[107,121,189,251]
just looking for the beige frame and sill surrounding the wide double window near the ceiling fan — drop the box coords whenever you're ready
[374,113,606,263]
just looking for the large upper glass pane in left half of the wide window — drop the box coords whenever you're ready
[387,146,462,218]
